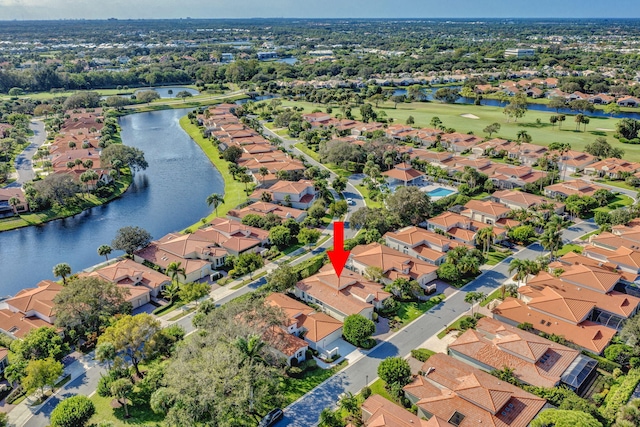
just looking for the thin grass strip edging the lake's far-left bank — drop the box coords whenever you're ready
[0,170,131,231]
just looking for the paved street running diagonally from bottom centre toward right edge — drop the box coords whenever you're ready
[277,222,598,427]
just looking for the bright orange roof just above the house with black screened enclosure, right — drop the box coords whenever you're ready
[493,298,617,354]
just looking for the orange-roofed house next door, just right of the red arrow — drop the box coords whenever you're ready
[346,243,438,291]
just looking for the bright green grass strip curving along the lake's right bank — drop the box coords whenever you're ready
[180,116,248,228]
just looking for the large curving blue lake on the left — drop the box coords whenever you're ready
[0,109,224,296]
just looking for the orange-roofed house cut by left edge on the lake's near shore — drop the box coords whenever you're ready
[0,280,62,338]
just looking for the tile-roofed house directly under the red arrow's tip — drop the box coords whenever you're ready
[294,265,391,322]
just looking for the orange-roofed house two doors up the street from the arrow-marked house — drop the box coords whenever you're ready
[383,226,462,265]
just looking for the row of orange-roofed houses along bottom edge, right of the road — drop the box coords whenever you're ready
[362,317,597,427]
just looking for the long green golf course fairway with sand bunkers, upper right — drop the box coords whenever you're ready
[283,100,640,161]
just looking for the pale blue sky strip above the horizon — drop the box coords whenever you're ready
[0,0,640,20]
